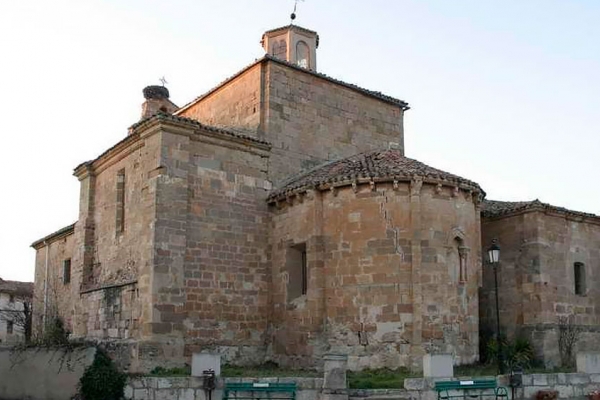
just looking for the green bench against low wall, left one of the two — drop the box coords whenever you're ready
[223,382,296,400]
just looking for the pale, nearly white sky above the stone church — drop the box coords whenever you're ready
[0,0,600,280]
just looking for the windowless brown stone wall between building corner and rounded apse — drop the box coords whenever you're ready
[151,127,270,364]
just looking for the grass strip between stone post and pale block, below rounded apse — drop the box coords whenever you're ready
[348,368,421,389]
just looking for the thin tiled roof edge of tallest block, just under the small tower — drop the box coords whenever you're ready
[175,54,410,114]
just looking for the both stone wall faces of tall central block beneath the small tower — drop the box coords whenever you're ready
[179,60,404,184]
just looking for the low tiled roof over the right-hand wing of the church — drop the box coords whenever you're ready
[481,199,600,222]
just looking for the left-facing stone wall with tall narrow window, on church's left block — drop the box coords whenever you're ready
[71,132,160,356]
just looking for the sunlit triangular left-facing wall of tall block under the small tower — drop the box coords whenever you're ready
[179,64,261,136]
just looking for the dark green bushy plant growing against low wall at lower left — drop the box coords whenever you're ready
[79,348,127,400]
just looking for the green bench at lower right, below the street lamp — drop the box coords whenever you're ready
[435,379,508,400]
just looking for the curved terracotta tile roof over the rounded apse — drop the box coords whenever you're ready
[268,149,485,201]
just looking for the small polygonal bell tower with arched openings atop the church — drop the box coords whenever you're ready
[260,24,319,71]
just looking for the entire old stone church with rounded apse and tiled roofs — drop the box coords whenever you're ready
[32,25,600,371]
